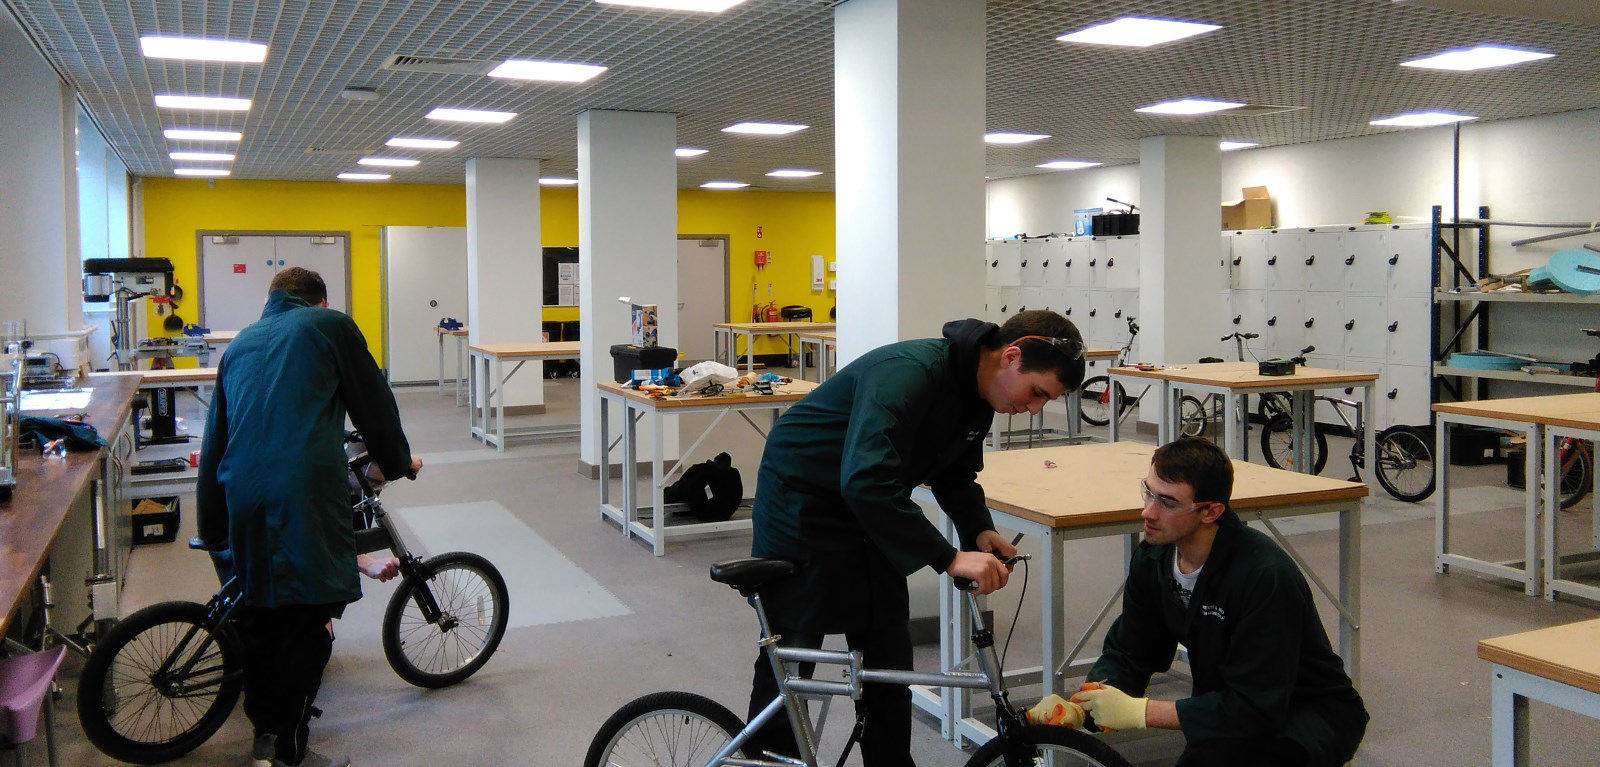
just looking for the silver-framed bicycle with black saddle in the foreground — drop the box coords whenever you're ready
[584,557,1128,767]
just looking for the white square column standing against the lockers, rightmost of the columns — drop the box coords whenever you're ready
[1139,136,1227,376]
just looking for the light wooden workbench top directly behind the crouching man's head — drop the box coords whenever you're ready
[978,442,1366,528]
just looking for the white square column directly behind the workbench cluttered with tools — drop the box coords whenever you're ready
[578,109,678,466]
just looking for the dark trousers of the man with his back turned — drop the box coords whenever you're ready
[235,605,338,764]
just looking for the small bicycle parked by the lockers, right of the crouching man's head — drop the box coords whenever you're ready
[1261,396,1434,503]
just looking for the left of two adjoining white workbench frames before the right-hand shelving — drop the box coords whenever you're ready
[1433,410,1544,596]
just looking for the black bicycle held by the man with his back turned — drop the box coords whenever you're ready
[78,434,509,764]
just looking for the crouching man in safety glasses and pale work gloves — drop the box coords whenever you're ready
[1072,437,1368,767]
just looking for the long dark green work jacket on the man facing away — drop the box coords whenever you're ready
[195,291,411,607]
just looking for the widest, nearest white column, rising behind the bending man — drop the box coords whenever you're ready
[834,0,984,365]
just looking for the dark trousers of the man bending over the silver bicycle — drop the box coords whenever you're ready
[746,549,915,767]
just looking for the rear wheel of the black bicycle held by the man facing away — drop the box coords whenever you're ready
[78,602,243,764]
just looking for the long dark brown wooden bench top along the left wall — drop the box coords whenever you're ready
[0,373,139,636]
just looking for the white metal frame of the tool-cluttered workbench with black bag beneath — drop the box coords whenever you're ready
[595,388,800,557]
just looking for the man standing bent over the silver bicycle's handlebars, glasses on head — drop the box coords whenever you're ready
[747,311,1085,767]
